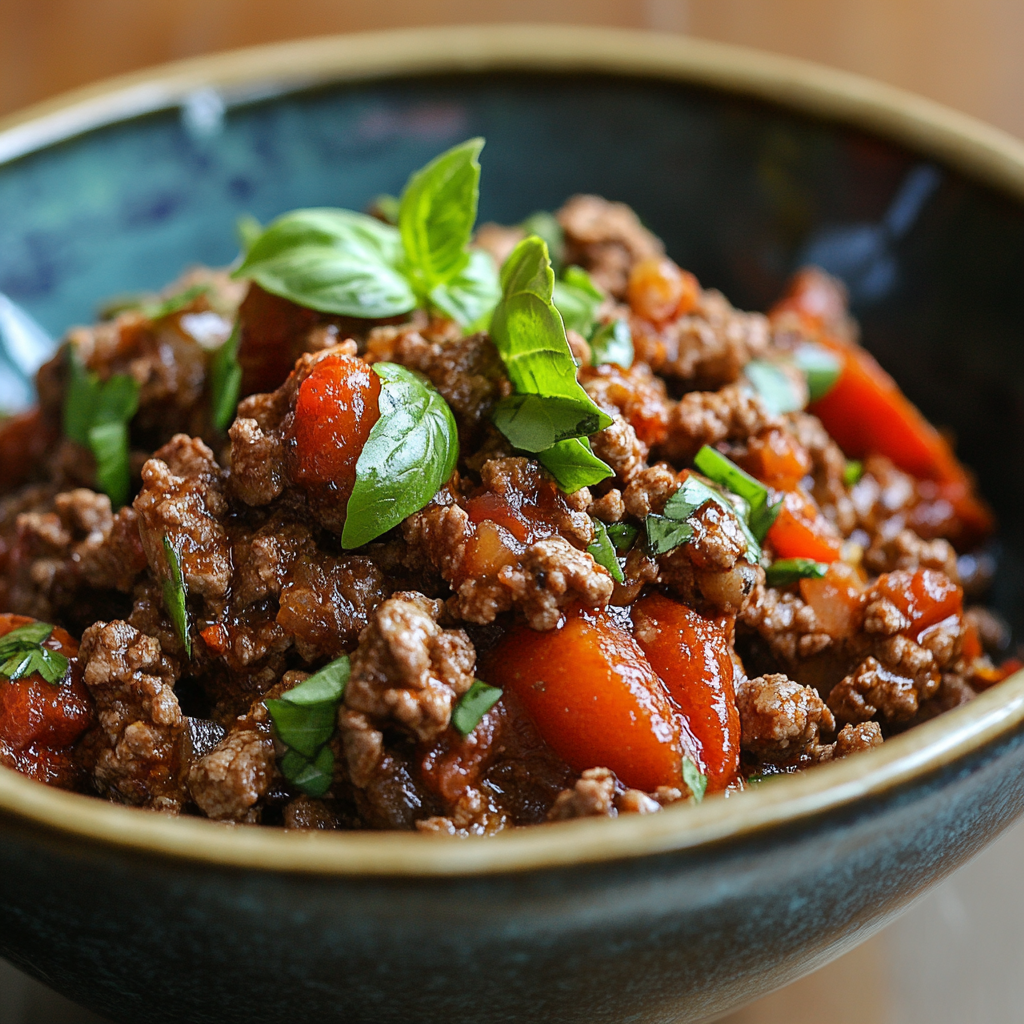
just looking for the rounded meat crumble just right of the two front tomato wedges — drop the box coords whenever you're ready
[736,673,836,764]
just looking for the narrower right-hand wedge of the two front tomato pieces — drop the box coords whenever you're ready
[633,594,739,791]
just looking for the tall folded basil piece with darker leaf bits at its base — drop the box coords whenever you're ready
[490,234,612,493]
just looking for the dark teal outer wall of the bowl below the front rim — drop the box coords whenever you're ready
[0,735,1024,1024]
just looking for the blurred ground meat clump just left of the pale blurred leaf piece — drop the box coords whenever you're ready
[660,385,783,463]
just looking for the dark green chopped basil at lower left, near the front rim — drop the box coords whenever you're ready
[263,654,351,797]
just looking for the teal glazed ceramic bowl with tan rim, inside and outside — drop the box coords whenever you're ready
[0,26,1024,1024]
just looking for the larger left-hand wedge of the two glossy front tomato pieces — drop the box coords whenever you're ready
[482,609,683,791]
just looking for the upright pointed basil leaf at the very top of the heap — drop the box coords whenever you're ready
[398,138,483,296]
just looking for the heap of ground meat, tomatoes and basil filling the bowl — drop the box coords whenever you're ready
[0,139,1017,835]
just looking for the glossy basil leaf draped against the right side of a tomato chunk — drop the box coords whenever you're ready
[341,362,459,549]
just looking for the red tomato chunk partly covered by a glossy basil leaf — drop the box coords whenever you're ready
[291,355,381,503]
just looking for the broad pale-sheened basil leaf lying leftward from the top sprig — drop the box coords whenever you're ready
[233,209,416,318]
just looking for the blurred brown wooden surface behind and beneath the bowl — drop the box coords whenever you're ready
[0,0,1024,1024]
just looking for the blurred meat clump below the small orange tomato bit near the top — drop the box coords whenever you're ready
[630,291,770,388]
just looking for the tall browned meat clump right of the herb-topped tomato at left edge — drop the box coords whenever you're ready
[78,622,187,814]
